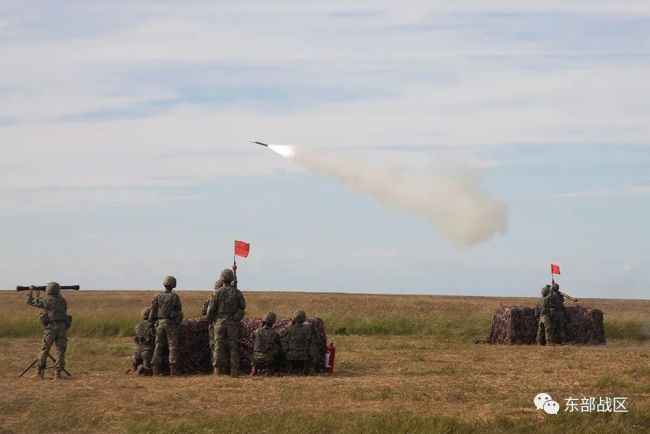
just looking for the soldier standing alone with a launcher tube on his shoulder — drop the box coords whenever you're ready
[27,282,72,379]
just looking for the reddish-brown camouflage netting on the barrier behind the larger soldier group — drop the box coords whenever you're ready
[178,318,327,374]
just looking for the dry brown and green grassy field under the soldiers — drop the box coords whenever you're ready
[0,291,650,433]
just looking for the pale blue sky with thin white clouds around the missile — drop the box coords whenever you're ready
[0,0,650,299]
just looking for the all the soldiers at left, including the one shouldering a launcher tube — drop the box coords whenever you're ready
[27,266,313,379]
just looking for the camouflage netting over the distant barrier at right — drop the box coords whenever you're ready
[484,306,605,345]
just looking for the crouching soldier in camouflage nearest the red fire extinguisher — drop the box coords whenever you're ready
[281,310,312,375]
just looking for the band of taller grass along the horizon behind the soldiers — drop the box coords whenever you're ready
[0,291,650,342]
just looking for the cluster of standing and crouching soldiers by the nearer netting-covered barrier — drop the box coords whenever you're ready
[132,265,312,377]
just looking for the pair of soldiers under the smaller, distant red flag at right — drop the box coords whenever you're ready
[535,281,568,345]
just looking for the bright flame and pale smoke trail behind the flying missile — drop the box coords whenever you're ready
[269,145,508,246]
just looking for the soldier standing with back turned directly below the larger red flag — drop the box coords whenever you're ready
[206,268,246,377]
